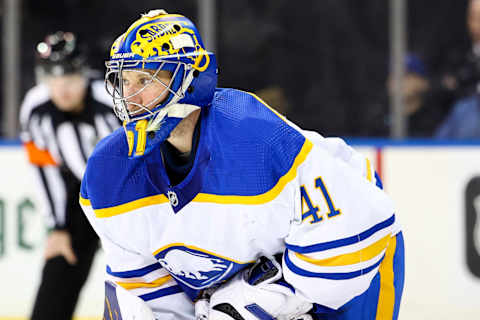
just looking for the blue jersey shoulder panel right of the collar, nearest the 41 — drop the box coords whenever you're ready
[202,89,306,196]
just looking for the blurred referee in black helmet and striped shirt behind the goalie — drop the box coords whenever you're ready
[20,31,119,320]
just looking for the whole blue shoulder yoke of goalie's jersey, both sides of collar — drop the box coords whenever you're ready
[81,89,309,214]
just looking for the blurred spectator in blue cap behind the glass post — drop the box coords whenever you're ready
[370,53,444,138]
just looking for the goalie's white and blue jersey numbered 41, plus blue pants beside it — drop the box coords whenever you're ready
[80,89,403,319]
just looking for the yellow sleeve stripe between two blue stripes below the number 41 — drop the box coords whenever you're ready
[295,235,391,267]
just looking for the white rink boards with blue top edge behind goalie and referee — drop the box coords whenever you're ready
[0,140,480,320]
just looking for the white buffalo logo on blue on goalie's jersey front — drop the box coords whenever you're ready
[155,246,247,290]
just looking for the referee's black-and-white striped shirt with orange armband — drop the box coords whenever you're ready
[20,80,120,229]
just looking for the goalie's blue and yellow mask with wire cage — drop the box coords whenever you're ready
[105,10,217,157]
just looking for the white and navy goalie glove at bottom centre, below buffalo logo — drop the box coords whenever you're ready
[195,257,312,320]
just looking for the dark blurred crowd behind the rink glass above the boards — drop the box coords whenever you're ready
[0,0,480,138]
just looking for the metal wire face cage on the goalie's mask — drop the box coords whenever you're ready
[105,59,193,123]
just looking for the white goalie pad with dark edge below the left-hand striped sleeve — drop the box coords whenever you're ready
[103,281,155,320]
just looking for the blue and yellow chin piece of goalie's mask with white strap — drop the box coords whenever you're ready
[124,103,200,158]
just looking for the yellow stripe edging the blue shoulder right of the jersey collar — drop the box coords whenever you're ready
[192,139,313,204]
